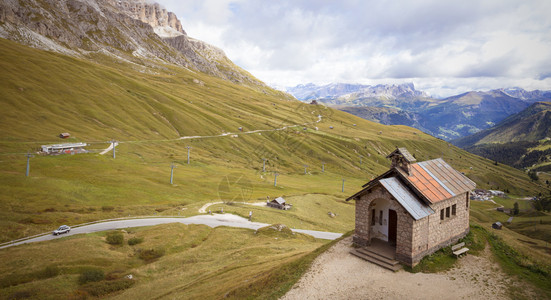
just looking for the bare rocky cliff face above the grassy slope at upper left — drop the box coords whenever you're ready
[0,0,265,87]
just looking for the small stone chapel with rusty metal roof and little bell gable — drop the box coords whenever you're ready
[347,148,476,269]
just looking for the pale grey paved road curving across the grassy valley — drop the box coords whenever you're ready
[0,214,342,249]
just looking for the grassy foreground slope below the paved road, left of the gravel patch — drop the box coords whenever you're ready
[0,224,324,299]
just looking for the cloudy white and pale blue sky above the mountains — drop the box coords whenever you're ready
[156,0,551,96]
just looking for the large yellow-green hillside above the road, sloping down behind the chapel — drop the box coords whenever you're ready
[0,36,541,241]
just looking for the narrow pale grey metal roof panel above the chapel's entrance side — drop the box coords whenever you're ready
[379,177,434,220]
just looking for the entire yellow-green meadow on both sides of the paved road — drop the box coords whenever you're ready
[0,39,550,299]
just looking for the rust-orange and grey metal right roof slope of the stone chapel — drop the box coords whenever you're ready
[405,158,476,203]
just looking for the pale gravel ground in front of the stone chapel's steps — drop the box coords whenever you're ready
[281,237,525,300]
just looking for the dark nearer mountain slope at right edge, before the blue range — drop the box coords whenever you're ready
[452,102,551,171]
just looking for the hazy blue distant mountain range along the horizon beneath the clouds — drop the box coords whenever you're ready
[287,83,551,140]
